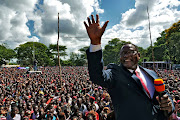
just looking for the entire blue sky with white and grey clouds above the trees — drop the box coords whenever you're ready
[0,0,180,56]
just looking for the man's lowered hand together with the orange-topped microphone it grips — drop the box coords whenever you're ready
[154,79,172,117]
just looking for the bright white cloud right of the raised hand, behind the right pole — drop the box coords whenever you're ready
[104,0,180,48]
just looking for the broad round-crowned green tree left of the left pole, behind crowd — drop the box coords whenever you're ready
[15,42,52,66]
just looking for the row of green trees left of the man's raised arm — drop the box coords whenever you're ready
[0,42,87,66]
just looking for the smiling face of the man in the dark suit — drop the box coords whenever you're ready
[120,44,140,70]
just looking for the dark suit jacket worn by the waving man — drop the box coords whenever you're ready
[86,49,174,120]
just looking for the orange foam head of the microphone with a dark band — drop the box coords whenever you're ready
[154,79,165,92]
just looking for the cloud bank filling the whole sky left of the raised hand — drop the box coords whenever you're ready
[0,0,104,52]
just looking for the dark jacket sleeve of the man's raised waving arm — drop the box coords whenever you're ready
[86,49,113,88]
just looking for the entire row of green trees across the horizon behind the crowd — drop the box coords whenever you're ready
[0,21,180,66]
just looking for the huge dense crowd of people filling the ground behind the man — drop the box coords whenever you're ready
[0,67,180,120]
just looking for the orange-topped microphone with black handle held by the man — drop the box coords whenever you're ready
[154,78,168,117]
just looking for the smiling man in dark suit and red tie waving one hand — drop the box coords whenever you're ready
[84,15,174,120]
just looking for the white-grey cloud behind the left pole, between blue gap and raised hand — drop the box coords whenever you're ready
[31,0,104,56]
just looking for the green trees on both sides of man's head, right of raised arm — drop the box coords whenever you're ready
[103,21,180,65]
